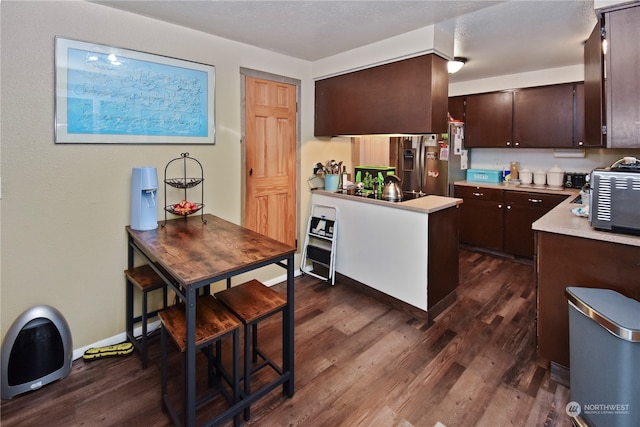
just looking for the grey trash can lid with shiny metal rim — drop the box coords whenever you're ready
[565,286,640,342]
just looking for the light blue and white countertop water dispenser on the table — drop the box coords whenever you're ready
[130,167,158,231]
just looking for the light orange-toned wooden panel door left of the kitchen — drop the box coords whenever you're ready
[244,76,296,246]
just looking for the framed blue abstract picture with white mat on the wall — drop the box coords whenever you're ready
[55,37,216,144]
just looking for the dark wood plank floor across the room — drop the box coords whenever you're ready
[0,249,571,427]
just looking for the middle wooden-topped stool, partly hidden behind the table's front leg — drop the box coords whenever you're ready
[158,295,240,425]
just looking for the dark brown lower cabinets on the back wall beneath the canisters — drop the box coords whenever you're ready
[455,185,567,258]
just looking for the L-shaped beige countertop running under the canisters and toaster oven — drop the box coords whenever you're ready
[455,181,640,246]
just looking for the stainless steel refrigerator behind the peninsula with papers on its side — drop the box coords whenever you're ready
[398,122,469,196]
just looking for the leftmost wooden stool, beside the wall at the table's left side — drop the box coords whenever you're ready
[124,264,168,369]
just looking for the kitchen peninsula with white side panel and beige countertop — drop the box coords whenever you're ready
[312,190,462,317]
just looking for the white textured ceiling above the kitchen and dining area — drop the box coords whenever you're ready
[95,0,596,82]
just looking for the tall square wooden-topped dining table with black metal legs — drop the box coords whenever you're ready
[126,214,296,426]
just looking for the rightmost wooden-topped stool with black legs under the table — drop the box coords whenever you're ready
[215,279,287,421]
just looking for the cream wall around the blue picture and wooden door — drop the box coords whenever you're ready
[0,1,340,349]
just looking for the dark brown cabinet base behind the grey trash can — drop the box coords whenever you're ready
[536,232,640,367]
